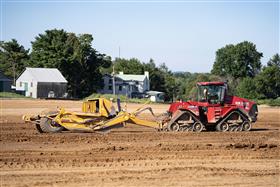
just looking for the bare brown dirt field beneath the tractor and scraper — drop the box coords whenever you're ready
[0,100,280,187]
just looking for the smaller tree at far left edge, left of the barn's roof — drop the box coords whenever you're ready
[0,39,29,84]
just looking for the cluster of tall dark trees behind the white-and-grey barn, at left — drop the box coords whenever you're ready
[0,29,111,98]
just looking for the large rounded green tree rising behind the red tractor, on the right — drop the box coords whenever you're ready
[211,41,263,79]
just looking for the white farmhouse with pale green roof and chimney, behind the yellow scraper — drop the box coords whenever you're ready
[99,71,150,97]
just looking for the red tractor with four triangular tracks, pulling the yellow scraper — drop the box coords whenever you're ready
[167,82,258,132]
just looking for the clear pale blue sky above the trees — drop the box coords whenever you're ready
[1,0,279,72]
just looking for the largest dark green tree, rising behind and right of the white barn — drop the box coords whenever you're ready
[29,29,111,97]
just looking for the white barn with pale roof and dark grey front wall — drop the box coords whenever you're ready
[16,68,67,98]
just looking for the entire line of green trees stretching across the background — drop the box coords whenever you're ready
[0,29,280,101]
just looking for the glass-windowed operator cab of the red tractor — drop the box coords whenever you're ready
[197,82,227,104]
